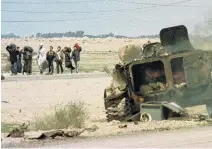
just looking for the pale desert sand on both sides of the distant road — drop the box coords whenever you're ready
[1,38,212,139]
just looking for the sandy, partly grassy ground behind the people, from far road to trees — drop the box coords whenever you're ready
[1,37,159,73]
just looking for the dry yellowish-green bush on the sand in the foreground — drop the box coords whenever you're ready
[30,101,88,130]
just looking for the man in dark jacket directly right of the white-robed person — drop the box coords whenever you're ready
[46,46,56,74]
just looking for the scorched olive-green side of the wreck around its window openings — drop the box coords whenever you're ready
[126,50,212,107]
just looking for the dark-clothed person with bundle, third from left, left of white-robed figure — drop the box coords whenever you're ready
[22,46,34,75]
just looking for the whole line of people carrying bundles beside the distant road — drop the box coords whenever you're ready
[6,43,82,75]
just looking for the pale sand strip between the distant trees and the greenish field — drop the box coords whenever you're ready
[1,37,159,53]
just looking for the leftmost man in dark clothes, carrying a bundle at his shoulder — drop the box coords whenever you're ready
[6,44,19,75]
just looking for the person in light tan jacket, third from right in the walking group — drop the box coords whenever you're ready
[56,46,63,74]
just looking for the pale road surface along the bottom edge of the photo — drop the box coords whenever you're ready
[2,126,212,148]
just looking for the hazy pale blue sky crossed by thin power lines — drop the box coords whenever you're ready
[1,0,212,36]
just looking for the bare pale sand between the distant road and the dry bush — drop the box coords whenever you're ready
[1,78,111,123]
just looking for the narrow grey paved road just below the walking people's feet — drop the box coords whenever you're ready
[2,73,110,82]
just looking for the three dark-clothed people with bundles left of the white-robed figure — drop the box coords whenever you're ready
[6,44,33,75]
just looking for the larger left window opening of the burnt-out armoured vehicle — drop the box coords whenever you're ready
[132,61,166,94]
